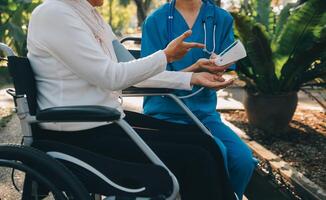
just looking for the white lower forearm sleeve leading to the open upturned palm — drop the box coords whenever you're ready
[135,71,192,90]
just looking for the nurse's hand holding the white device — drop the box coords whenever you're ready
[183,58,233,74]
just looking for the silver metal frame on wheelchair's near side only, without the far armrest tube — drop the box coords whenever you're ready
[0,43,179,200]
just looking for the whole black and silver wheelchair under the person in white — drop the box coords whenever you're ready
[0,38,236,200]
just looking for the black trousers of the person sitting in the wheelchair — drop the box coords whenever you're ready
[35,112,235,200]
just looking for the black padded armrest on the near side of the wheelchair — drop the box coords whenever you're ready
[36,105,121,122]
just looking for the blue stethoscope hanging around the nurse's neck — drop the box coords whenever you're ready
[168,0,217,55]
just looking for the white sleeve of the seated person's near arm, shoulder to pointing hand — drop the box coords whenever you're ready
[30,3,167,91]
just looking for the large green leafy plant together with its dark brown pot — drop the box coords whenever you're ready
[233,0,326,132]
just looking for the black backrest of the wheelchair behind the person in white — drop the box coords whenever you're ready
[8,56,37,115]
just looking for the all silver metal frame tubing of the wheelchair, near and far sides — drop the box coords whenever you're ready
[0,37,227,200]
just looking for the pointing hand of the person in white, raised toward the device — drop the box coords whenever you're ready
[164,30,204,63]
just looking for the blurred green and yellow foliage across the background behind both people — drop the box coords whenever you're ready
[0,0,326,89]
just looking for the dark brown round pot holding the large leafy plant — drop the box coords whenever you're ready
[244,91,298,134]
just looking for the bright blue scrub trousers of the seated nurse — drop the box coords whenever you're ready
[146,112,257,200]
